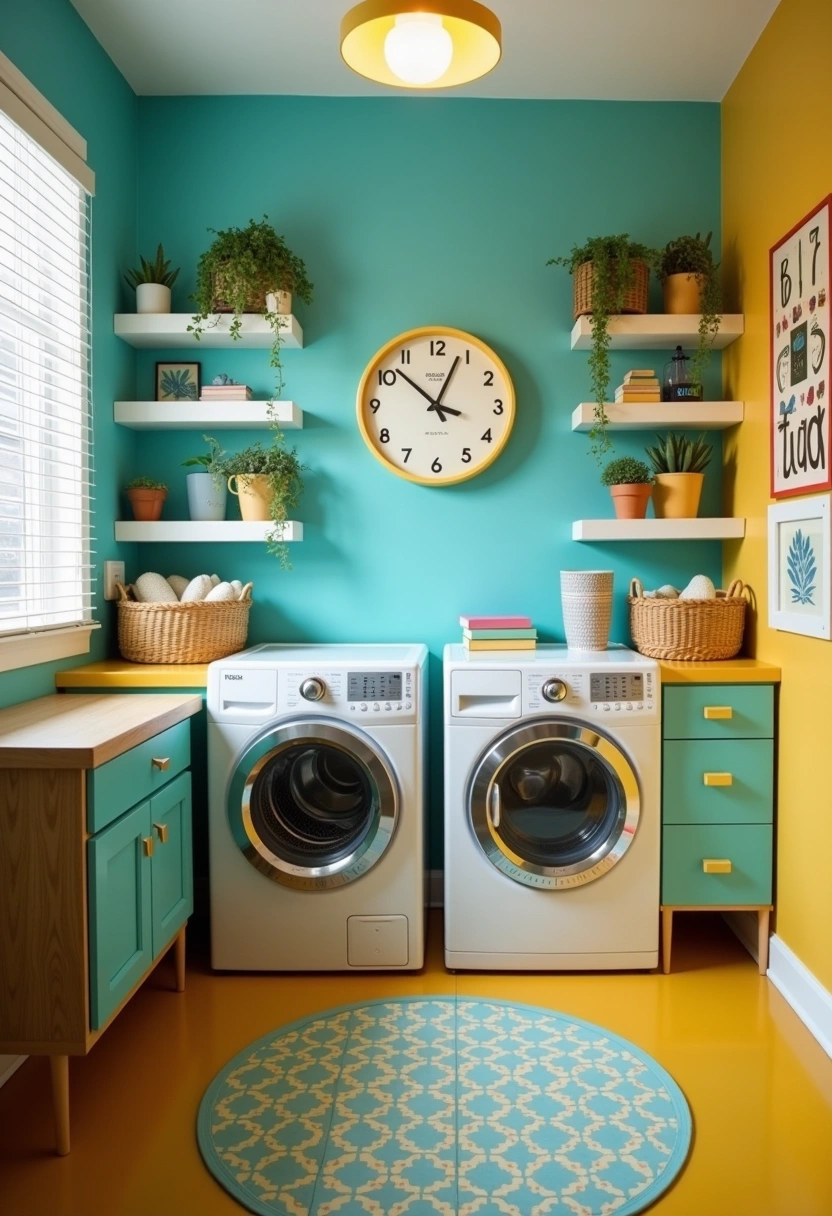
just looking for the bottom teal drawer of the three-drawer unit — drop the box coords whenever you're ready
[662,823,772,906]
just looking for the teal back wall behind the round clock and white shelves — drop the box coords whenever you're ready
[131,97,720,863]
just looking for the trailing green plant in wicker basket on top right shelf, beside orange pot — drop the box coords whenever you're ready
[546,232,658,465]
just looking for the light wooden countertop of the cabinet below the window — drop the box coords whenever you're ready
[0,692,202,769]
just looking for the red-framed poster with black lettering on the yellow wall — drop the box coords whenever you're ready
[769,195,832,499]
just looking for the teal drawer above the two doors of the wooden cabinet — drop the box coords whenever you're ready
[86,720,191,832]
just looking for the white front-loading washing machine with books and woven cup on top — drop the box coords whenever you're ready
[444,646,662,970]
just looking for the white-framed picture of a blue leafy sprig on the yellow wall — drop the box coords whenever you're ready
[769,494,832,641]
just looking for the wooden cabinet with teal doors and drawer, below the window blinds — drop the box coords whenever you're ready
[0,694,202,1154]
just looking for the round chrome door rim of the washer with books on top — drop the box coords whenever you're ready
[466,719,641,889]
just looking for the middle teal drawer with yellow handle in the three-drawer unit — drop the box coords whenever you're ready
[662,739,774,823]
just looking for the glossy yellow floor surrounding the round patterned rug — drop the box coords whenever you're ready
[0,916,832,1216]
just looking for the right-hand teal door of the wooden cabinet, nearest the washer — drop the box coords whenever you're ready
[150,772,193,958]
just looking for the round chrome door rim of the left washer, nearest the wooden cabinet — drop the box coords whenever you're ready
[227,717,400,891]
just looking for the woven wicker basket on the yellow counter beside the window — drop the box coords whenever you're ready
[118,582,253,663]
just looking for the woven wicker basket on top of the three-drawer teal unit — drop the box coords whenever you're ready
[628,579,751,662]
